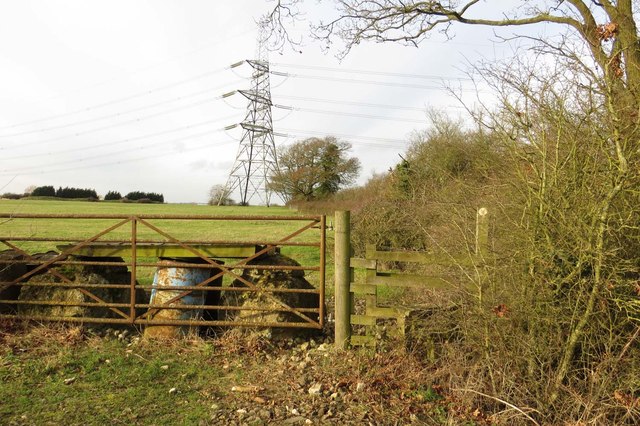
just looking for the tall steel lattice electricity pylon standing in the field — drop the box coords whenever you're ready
[218,33,278,206]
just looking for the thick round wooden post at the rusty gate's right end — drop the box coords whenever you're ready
[334,211,351,349]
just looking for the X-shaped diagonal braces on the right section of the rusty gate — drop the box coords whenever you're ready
[139,219,318,325]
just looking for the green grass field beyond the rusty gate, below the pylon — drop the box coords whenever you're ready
[0,200,333,285]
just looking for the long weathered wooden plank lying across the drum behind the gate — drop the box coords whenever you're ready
[58,243,257,259]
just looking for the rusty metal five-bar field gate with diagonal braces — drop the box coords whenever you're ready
[0,214,326,329]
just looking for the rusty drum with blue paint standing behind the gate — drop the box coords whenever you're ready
[144,260,211,338]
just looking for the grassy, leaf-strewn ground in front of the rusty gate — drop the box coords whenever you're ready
[0,322,463,426]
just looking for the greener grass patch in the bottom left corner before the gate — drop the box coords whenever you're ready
[0,334,233,425]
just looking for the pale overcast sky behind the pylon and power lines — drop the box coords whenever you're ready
[0,0,552,202]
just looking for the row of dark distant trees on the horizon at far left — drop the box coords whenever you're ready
[2,185,164,203]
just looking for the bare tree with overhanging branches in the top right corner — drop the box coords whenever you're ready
[267,0,640,120]
